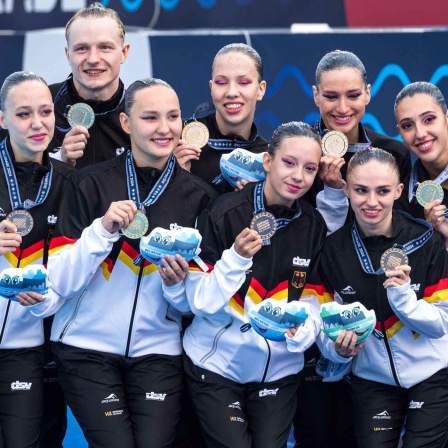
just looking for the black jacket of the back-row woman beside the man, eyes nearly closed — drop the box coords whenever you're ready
[191,113,268,194]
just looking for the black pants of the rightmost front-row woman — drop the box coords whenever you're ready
[352,369,448,448]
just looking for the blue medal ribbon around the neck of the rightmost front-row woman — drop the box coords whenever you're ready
[352,210,434,275]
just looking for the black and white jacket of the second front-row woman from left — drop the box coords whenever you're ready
[30,153,216,357]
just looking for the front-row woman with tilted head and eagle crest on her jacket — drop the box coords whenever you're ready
[173,122,326,448]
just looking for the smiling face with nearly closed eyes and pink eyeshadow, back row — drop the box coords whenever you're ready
[210,51,266,139]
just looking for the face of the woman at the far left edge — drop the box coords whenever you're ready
[0,80,55,163]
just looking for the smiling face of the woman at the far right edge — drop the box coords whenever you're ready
[395,94,448,169]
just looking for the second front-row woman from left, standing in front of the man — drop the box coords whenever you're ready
[26,78,215,448]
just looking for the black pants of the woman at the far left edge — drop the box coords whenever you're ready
[0,347,43,448]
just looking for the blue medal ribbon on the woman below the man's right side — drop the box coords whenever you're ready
[126,150,176,210]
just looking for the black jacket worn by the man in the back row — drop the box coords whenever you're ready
[49,75,130,168]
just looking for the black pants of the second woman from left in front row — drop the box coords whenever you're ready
[53,343,183,448]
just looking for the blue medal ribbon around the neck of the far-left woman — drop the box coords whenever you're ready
[0,139,53,210]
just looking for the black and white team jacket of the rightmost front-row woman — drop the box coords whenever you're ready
[321,212,448,388]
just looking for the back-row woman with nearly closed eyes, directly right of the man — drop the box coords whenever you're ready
[174,43,268,193]
